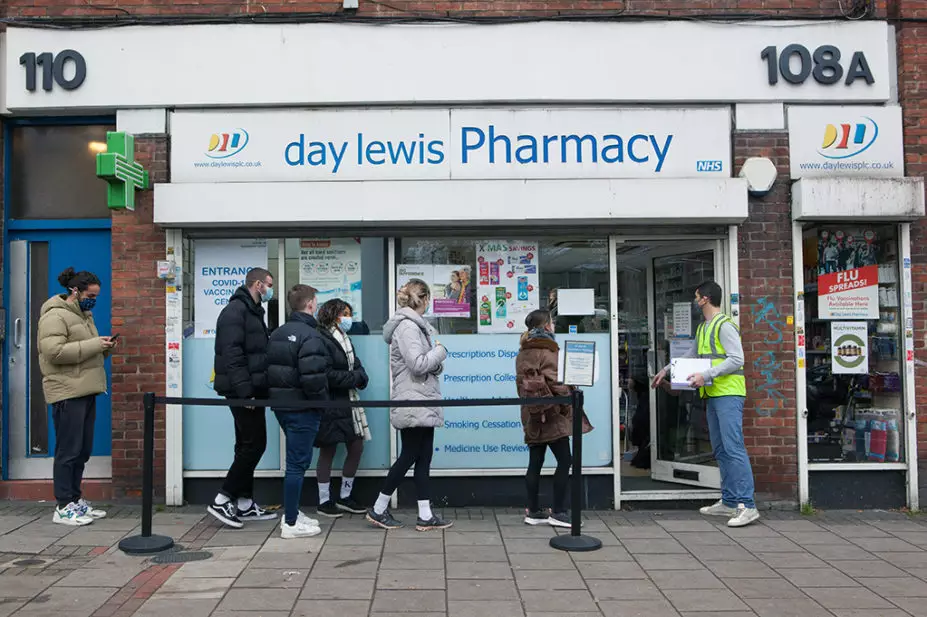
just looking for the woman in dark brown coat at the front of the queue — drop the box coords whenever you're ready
[515,310,573,527]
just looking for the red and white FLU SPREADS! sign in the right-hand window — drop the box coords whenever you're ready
[818,266,879,319]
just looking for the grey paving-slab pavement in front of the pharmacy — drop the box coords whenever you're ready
[0,502,927,617]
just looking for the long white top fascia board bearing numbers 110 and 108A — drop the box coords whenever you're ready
[0,20,895,111]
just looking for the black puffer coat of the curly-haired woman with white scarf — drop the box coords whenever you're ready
[315,328,368,448]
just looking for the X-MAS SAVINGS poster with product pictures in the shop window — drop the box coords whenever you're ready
[476,240,541,334]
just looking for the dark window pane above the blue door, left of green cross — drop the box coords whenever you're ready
[10,125,116,219]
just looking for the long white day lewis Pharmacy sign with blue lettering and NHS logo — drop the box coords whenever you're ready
[171,108,731,183]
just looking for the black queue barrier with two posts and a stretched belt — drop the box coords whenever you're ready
[119,390,602,555]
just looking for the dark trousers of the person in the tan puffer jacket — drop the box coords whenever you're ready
[52,396,97,506]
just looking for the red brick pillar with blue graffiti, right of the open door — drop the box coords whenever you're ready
[734,132,798,499]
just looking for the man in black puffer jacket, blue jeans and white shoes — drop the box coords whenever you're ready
[267,285,331,540]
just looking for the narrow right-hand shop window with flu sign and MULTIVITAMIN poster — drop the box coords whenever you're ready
[799,224,905,463]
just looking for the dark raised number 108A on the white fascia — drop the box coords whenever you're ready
[760,44,875,86]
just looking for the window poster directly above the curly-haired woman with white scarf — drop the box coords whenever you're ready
[299,238,363,321]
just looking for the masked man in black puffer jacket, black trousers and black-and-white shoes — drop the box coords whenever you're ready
[206,268,277,529]
